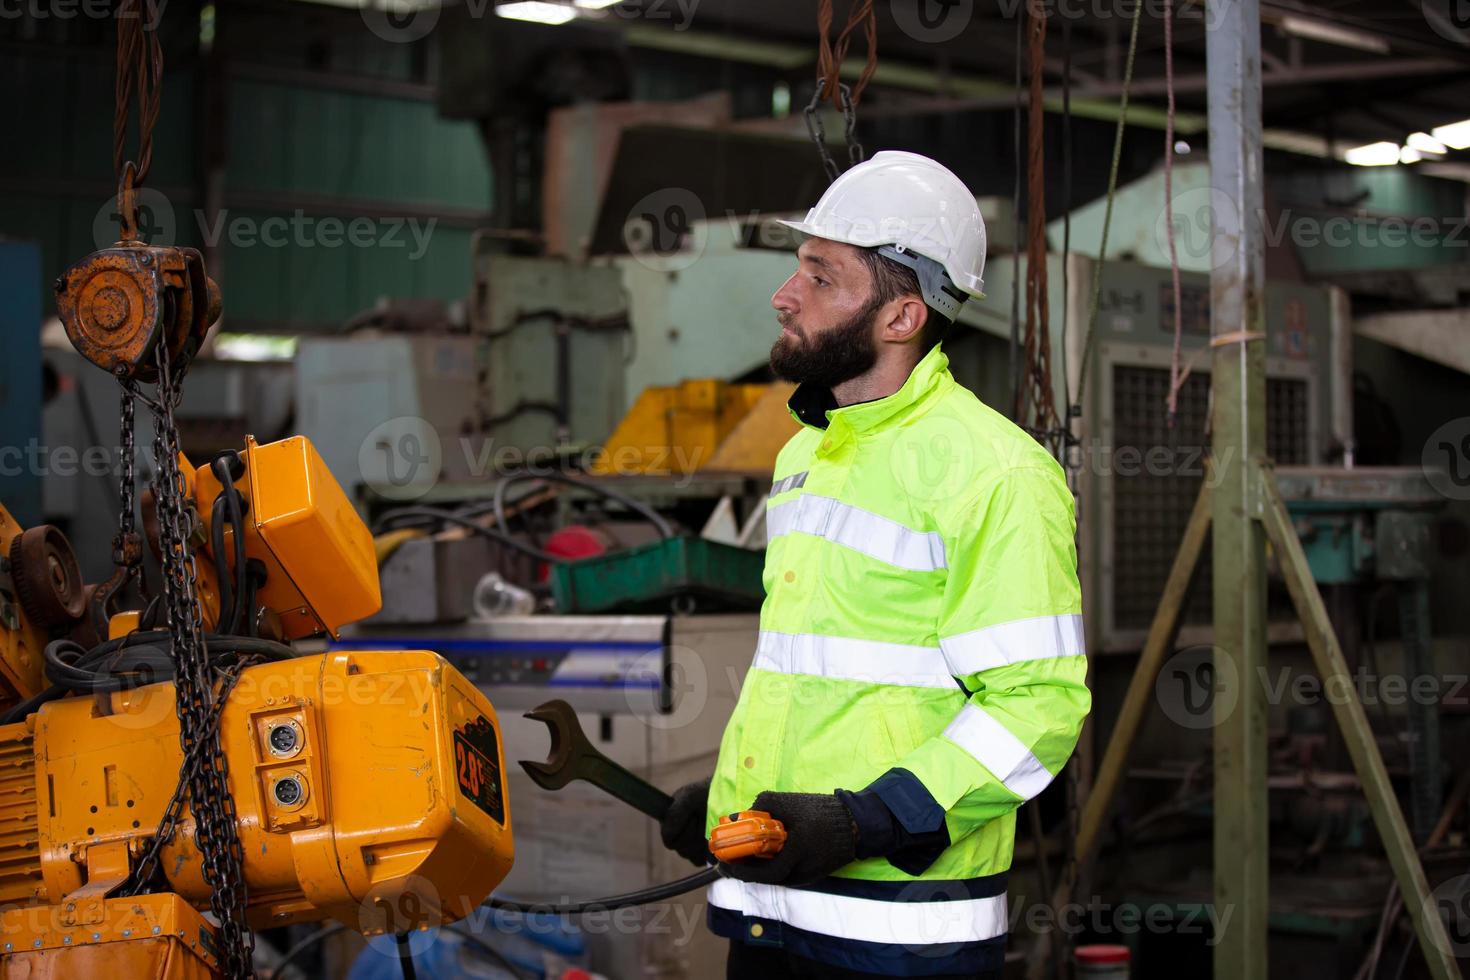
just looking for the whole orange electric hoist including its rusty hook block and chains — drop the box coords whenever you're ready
[0,224,513,980]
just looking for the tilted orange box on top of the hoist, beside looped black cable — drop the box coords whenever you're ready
[187,435,382,639]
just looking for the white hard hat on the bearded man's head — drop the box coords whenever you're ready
[781,150,985,308]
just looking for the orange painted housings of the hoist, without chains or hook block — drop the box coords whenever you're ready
[0,436,513,980]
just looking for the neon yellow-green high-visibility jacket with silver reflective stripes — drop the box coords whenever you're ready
[707,347,1091,976]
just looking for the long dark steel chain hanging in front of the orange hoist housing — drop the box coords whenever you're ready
[128,344,254,980]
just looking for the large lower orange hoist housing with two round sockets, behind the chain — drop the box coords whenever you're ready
[0,651,513,936]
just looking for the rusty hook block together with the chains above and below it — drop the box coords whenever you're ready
[91,0,254,980]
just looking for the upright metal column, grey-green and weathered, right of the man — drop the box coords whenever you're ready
[1205,0,1269,980]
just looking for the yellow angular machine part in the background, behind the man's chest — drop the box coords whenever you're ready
[592,378,797,476]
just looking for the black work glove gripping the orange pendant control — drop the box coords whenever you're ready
[720,790,857,884]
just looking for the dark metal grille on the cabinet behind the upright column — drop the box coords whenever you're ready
[1103,364,1310,630]
